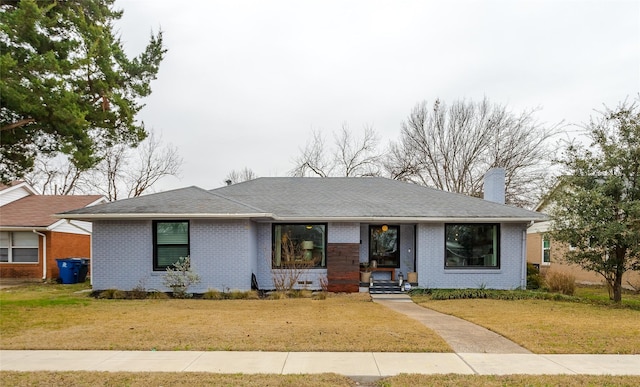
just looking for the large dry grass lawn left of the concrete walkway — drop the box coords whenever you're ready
[0,285,451,352]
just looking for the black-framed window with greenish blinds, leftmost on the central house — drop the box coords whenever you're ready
[153,220,189,270]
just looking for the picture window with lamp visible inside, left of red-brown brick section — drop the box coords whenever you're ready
[273,224,327,268]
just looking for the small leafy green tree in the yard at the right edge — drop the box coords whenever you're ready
[551,99,640,303]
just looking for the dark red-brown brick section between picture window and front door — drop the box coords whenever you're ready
[327,243,360,293]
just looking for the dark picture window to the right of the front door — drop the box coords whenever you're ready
[444,224,500,268]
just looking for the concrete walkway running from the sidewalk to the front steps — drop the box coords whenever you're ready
[371,294,531,354]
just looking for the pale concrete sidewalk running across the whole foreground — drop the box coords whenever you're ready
[0,350,640,377]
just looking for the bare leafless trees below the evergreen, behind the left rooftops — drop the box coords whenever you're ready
[25,132,182,200]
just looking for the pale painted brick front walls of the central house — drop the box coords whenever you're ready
[92,220,526,292]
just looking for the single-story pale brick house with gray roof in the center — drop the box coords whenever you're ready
[58,177,545,292]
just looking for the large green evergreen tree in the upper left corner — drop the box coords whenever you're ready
[0,0,166,182]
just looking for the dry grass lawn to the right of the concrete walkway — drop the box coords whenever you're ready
[414,297,640,354]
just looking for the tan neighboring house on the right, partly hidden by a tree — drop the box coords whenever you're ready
[527,197,640,288]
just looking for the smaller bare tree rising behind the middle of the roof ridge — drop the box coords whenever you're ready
[290,124,381,177]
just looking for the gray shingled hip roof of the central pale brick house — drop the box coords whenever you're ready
[58,177,544,221]
